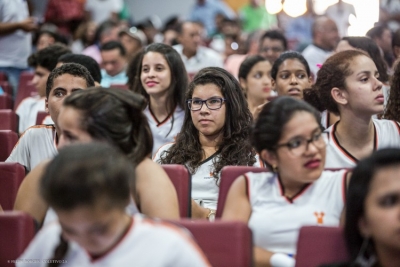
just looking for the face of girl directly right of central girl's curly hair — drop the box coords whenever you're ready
[240,61,272,103]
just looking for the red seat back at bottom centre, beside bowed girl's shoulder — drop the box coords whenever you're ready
[177,220,253,267]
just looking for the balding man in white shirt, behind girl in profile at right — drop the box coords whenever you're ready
[302,16,339,80]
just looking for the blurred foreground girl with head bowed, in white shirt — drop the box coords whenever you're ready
[17,143,209,267]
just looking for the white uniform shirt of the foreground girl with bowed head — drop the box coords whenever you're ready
[17,215,210,267]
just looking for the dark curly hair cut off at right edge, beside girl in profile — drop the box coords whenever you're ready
[383,62,400,121]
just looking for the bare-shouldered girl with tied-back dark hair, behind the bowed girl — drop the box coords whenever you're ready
[14,88,179,224]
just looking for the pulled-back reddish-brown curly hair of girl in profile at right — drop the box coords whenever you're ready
[306,50,370,115]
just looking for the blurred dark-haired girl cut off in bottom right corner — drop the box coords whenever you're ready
[324,148,400,267]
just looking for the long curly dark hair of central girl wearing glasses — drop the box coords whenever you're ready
[160,67,256,180]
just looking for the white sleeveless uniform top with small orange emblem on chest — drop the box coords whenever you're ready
[245,170,346,255]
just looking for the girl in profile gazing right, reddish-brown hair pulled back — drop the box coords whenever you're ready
[313,50,400,168]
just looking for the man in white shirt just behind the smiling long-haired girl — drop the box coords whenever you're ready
[174,21,223,74]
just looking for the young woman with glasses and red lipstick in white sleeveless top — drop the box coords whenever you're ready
[222,97,348,267]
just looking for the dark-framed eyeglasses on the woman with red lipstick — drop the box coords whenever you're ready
[276,132,326,156]
